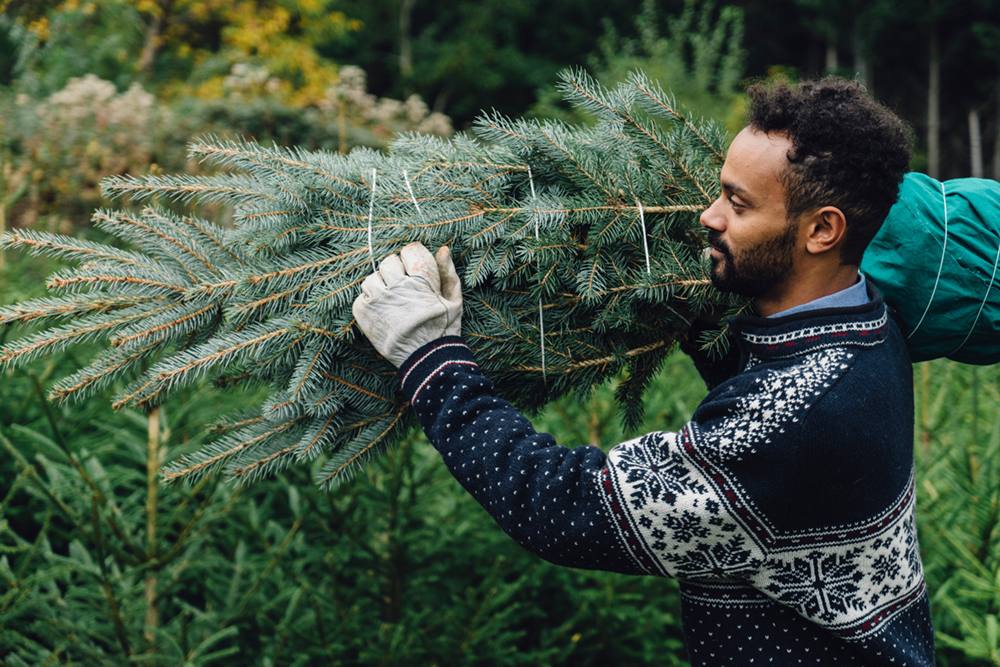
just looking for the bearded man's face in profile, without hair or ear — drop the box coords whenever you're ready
[701,127,799,297]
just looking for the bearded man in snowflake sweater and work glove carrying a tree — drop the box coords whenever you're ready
[354,79,934,665]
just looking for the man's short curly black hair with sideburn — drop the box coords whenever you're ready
[746,77,913,265]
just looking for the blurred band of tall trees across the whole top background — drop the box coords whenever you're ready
[0,0,1000,178]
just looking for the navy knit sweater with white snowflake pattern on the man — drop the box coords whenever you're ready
[399,294,934,665]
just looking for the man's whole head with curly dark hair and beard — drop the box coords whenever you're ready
[702,78,911,306]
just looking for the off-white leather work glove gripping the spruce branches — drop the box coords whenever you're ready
[353,243,462,368]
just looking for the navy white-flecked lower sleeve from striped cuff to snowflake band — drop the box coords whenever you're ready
[399,336,655,574]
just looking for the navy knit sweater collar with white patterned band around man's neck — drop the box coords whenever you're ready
[730,281,889,359]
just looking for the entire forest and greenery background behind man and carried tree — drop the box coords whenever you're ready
[0,0,1000,666]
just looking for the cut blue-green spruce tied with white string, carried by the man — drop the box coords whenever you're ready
[0,72,741,486]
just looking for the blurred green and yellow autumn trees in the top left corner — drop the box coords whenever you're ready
[0,0,361,103]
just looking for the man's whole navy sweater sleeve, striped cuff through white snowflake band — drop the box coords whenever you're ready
[399,337,761,578]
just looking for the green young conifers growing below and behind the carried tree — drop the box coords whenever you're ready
[0,248,1000,667]
